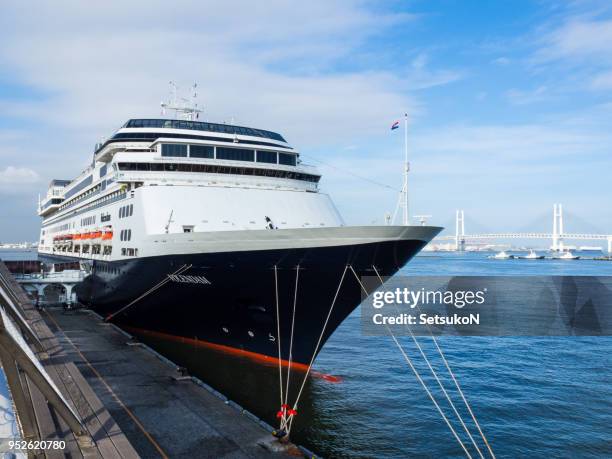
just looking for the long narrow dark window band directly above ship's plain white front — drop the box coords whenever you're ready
[118,163,321,183]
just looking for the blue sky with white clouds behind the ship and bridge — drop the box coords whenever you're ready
[0,0,612,241]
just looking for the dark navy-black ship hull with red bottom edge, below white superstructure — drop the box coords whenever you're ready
[65,239,426,367]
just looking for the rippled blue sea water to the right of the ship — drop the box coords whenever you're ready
[306,253,612,458]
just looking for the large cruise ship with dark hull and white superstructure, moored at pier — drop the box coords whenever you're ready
[39,102,441,367]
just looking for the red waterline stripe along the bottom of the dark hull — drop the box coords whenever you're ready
[122,326,342,383]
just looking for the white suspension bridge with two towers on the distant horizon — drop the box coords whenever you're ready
[433,204,612,254]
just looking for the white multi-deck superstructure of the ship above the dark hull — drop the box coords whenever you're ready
[39,119,343,260]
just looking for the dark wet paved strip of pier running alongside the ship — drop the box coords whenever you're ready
[42,308,304,458]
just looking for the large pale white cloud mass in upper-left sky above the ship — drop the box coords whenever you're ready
[0,1,436,146]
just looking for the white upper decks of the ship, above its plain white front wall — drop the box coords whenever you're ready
[39,118,320,223]
